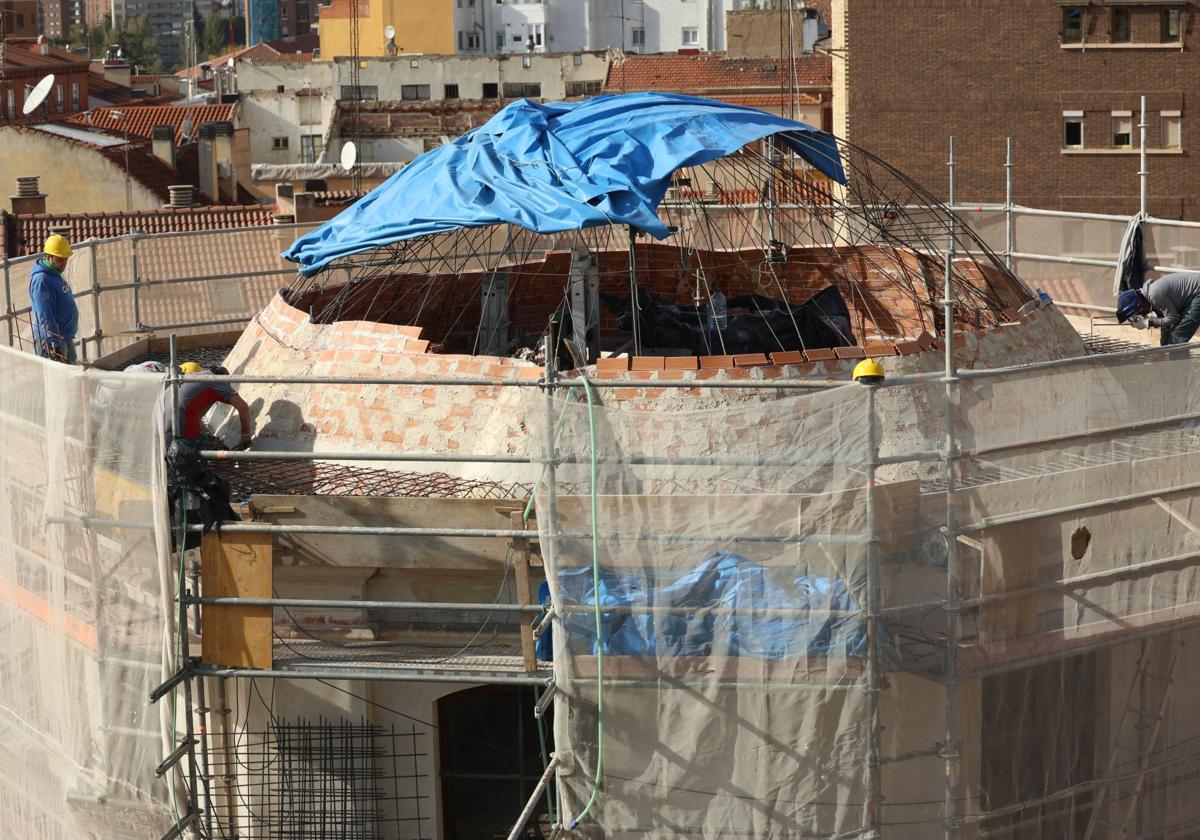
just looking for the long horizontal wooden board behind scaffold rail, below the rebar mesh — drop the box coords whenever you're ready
[251,494,524,571]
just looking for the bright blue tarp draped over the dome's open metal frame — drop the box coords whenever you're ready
[283,94,845,275]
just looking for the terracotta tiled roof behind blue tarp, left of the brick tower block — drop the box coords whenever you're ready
[605,53,833,94]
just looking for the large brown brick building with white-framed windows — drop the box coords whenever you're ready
[830,0,1200,218]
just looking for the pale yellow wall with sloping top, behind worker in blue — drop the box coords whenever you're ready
[0,126,163,212]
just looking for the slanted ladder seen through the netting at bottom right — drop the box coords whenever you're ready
[1084,636,1183,840]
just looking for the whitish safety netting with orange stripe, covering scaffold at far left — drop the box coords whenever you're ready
[0,348,175,840]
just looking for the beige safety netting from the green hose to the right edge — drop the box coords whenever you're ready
[537,345,1200,840]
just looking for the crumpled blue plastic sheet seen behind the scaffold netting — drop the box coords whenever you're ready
[549,552,866,660]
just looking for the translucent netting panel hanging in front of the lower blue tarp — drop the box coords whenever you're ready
[527,388,869,838]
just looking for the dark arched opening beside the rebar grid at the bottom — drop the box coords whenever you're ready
[438,685,553,840]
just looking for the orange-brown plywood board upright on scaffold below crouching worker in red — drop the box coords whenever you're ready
[200,533,272,668]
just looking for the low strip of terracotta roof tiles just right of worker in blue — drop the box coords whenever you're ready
[8,204,275,257]
